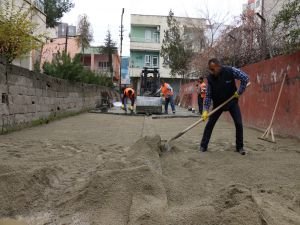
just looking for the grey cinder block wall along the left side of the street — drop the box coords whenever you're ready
[0,64,119,133]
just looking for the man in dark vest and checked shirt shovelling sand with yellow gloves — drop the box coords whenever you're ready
[200,58,249,155]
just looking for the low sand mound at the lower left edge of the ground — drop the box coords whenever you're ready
[0,165,57,217]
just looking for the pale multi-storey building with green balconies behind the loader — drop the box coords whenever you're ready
[129,14,205,94]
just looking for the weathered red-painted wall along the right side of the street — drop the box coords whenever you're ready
[180,52,300,138]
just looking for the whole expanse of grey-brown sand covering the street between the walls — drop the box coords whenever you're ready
[0,114,300,225]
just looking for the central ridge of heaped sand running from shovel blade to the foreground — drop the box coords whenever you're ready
[59,136,167,225]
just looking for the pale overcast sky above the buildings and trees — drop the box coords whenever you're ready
[62,0,247,55]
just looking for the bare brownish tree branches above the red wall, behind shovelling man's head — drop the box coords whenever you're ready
[194,6,266,73]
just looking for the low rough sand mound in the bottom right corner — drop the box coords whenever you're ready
[214,184,300,225]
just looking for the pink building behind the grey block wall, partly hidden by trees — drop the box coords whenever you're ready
[41,37,120,81]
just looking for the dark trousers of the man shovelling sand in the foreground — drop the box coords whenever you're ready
[200,101,244,150]
